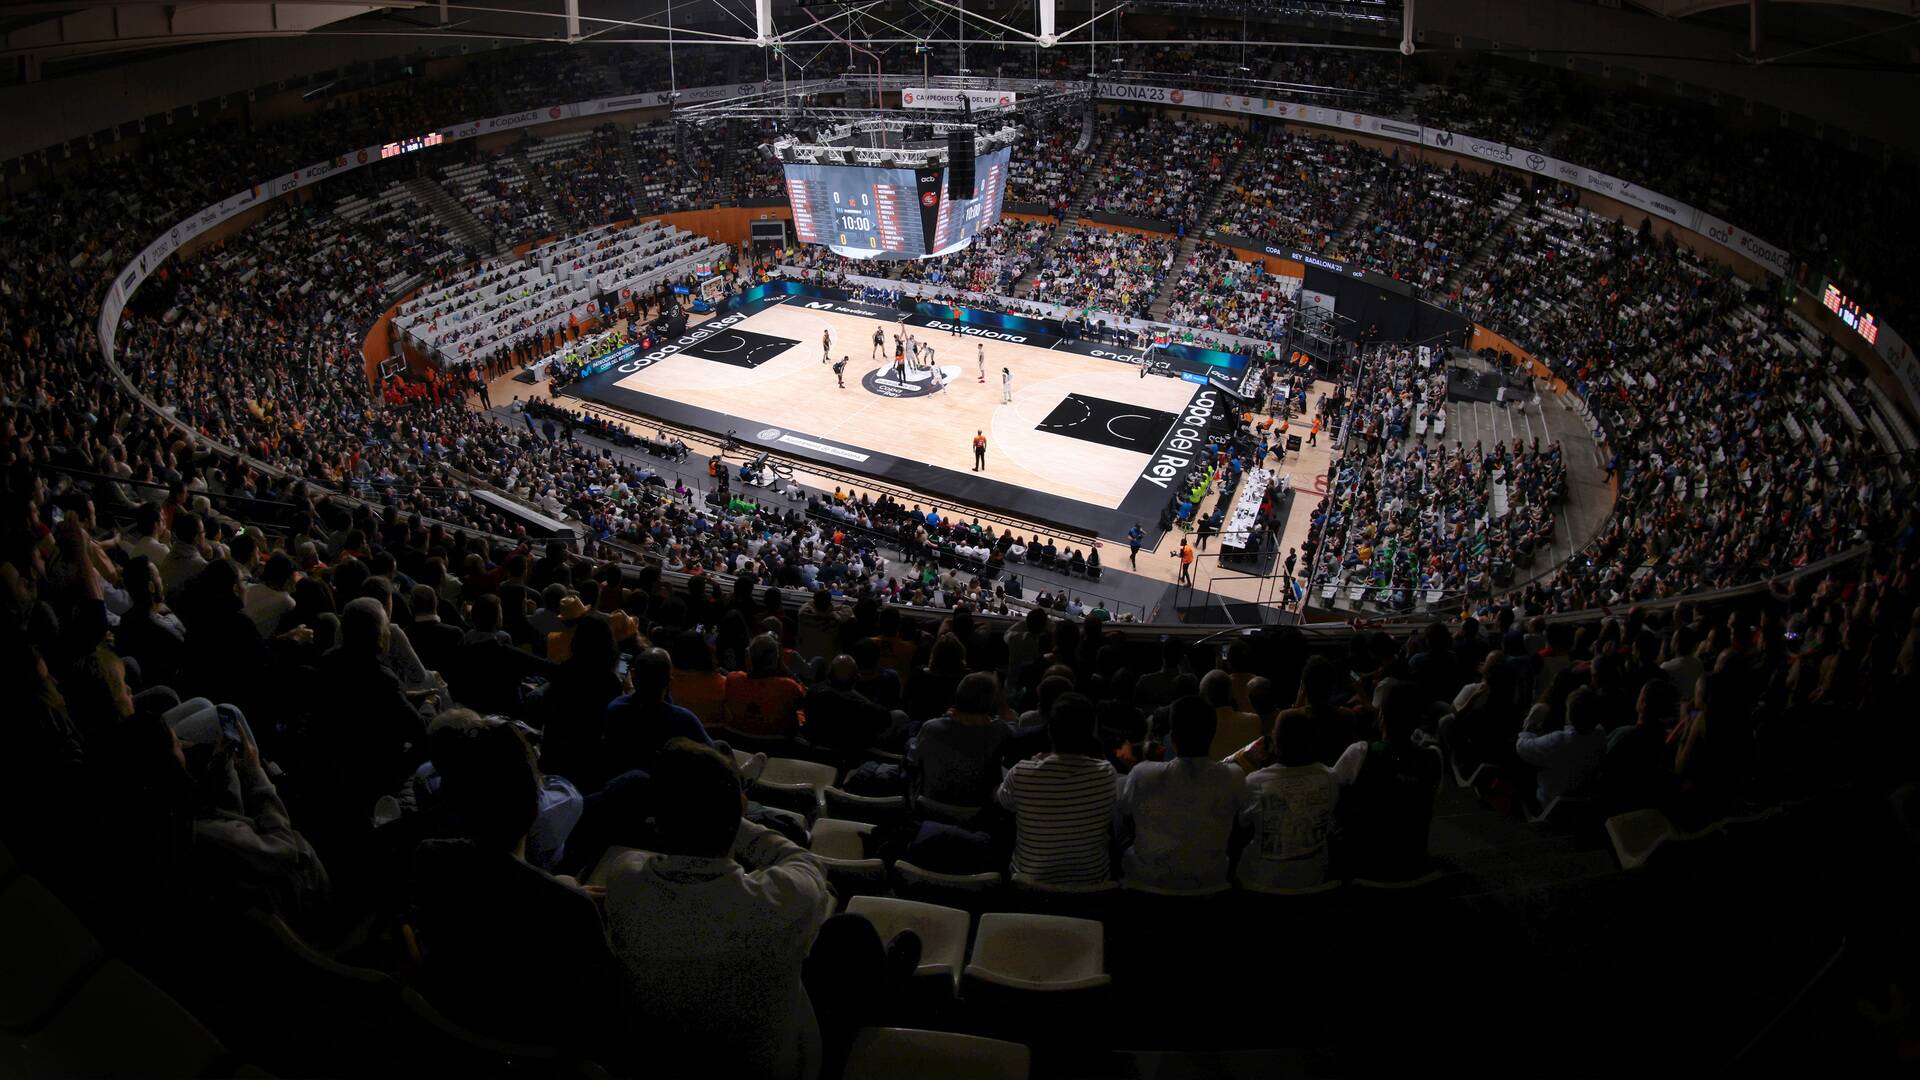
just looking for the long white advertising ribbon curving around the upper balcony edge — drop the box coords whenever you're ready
[100,75,1920,417]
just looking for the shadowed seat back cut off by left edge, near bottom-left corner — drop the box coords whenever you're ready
[0,874,106,1032]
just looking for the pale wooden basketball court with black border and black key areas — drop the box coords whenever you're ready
[563,296,1233,540]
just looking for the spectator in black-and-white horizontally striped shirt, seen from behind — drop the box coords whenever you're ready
[998,694,1116,886]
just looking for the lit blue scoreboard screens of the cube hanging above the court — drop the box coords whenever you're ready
[785,146,1012,259]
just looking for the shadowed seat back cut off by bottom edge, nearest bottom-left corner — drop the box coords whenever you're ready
[23,961,227,1080]
